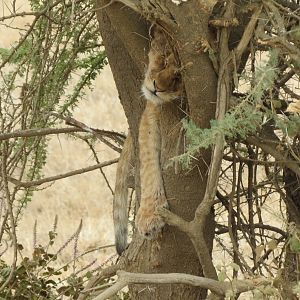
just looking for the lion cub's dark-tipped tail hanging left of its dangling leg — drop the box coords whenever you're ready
[113,133,133,255]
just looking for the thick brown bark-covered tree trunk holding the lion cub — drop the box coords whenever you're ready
[97,0,217,300]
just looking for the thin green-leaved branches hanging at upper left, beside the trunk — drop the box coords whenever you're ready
[0,0,107,211]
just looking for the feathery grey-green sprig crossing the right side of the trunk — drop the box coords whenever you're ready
[173,50,300,168]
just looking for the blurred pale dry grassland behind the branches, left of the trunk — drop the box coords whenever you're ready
[0,0,127,265]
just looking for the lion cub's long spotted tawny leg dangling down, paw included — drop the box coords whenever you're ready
[136,102,168,238]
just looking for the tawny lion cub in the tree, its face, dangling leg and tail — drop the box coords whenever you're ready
[114,28,182,254]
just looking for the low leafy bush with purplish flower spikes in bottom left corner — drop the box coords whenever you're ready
[0,220,106,300]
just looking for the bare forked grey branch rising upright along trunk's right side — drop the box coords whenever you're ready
[159,1,239,279]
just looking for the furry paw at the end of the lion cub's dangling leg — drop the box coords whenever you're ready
[136,197,168,239]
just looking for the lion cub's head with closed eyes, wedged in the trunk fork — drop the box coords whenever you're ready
[142,26,182,104]
